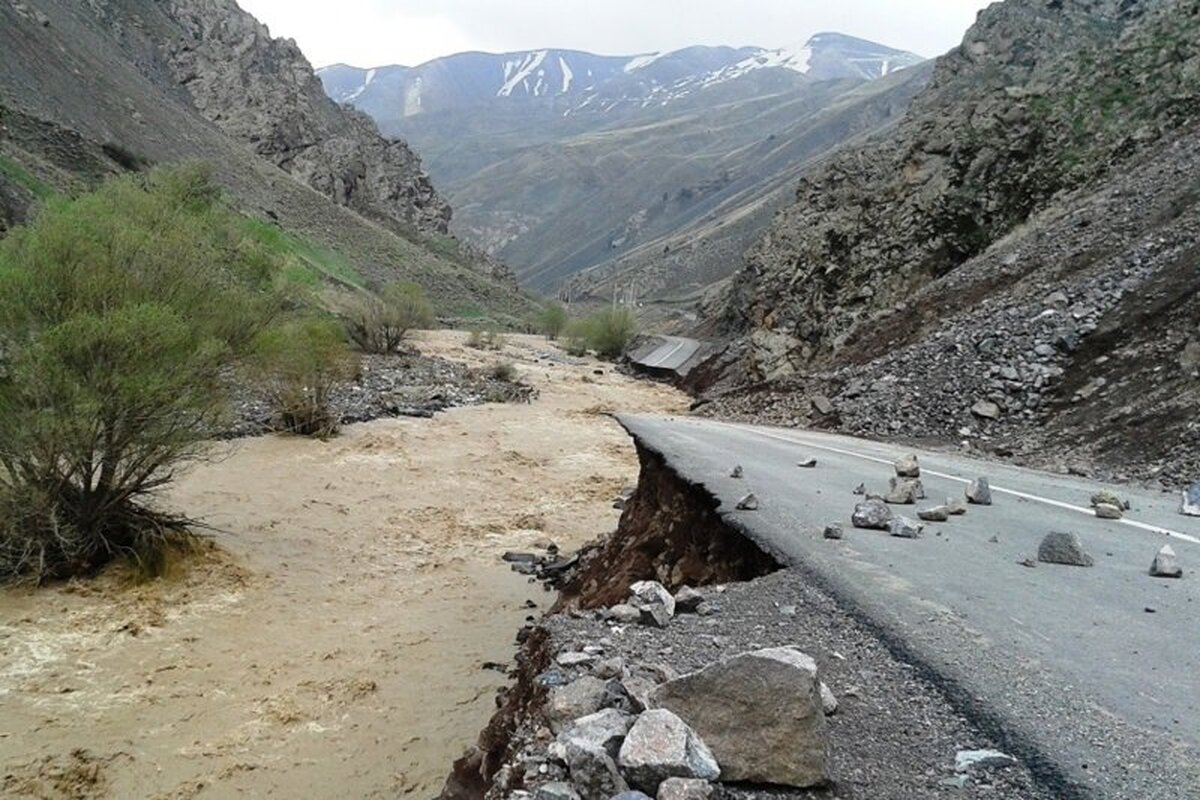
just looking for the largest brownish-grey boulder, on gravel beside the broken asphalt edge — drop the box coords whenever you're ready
[652,648,828,788]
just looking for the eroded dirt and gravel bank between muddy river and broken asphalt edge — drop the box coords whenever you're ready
[443,422,1072,800]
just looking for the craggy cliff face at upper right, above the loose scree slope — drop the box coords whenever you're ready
[722,0,1200,362]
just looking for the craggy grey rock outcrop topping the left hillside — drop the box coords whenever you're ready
[162,0,450,234]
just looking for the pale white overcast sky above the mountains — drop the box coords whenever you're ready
[238,0,989,67]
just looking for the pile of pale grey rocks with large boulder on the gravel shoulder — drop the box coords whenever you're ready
[530,642,838,800]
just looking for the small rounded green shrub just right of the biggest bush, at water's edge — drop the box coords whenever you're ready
[250,318,359,439]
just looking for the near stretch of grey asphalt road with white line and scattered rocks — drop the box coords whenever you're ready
[620,417,1200,799]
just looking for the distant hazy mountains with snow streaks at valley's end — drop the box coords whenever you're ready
[320,34,920,289]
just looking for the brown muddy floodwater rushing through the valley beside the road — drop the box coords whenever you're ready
[0,332,686,798]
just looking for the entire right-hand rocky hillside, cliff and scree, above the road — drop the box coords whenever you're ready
[697,0,1200,485]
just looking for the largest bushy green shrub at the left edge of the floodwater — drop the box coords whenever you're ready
[0,167,280,582]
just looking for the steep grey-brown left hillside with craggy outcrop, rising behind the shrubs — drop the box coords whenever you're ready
[0,0,529,317]
